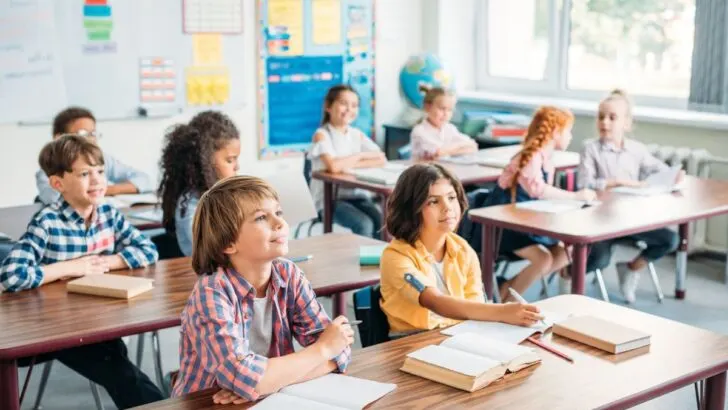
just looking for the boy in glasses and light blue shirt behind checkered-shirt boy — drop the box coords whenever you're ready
[35,107,153,205]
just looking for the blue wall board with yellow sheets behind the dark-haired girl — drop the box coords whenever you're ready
[258,0,374,159]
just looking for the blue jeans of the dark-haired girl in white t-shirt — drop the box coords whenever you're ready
[334,198,382,238]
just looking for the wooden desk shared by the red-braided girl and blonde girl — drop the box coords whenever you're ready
[469,177,728,299]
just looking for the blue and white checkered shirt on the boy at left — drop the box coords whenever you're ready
[0,200,158,292]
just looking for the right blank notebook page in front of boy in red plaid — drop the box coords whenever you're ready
[281,373,397,409]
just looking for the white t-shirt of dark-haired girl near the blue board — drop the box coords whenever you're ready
[308,124,382,211]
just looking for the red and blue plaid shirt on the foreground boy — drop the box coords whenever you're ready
[172,260,351,401]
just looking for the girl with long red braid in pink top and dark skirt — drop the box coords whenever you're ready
[485,107,596,301]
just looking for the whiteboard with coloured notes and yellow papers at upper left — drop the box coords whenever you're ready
[0,0,246,124]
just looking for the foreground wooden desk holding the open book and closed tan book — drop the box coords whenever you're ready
[134,295,728,410]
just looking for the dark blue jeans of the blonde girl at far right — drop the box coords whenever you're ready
[586,228,680,272]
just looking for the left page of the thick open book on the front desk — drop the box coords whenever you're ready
[407,345,502,377]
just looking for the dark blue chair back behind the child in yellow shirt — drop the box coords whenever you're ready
[354,285,389,347]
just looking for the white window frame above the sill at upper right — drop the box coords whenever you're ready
[475,0,688,110]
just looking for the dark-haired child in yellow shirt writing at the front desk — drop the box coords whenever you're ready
[380,164,540,337]
